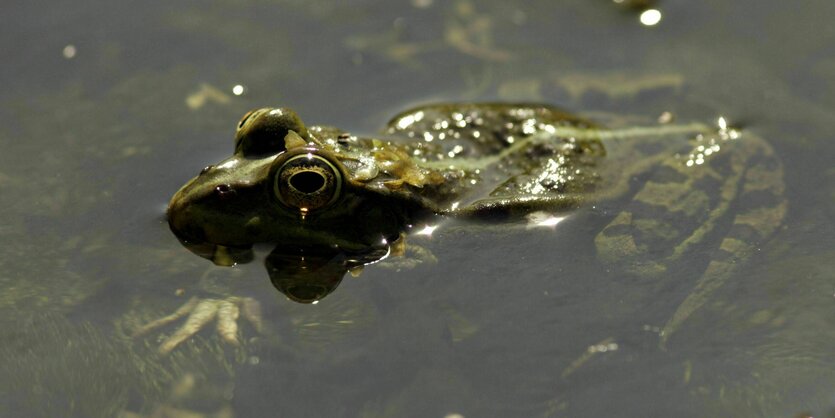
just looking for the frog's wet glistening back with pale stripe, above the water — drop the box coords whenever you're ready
[386,103,605,217]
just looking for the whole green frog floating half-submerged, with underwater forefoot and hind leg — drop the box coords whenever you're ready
[147,102,787,351]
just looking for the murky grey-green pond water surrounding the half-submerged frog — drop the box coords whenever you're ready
[0,0,835,417]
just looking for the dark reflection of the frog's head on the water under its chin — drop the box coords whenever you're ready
[174,230,389,303]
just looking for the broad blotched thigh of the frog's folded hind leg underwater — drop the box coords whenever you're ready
[595,139,744,277]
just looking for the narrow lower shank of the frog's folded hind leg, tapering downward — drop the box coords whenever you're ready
[660,140,787,347]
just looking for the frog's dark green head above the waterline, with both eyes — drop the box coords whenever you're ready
[168,108,390,258]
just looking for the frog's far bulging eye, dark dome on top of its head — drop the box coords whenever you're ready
[235,107,307,158]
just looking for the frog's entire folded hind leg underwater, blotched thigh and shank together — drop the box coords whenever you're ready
[595,131,786,345]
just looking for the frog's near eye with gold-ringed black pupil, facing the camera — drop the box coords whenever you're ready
[273,153,342,211]
